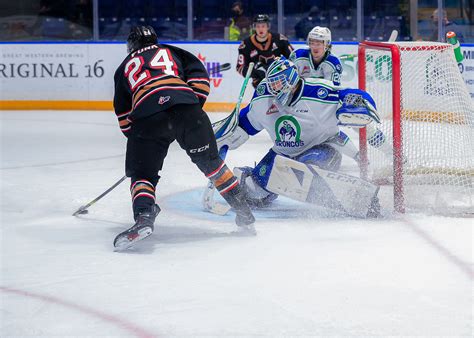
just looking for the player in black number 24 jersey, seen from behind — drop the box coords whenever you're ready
[114,26,255,250]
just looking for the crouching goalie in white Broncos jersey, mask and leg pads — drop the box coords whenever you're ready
[217,57,379,217]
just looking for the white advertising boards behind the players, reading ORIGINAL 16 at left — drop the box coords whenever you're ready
[0,43,474,110]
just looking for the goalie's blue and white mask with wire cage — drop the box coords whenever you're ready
[265,56,300,106]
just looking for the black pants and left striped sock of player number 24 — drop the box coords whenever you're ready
[125,104,222,215]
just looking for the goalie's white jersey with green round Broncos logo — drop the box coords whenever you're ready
[239,79,342,157]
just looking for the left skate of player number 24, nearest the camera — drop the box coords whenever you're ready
[114,204,160,251]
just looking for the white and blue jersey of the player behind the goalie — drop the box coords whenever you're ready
[290,48,342,86]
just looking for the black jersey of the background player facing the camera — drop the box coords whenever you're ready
[237,33,293,86]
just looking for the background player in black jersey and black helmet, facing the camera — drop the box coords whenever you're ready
[237,14,293,88]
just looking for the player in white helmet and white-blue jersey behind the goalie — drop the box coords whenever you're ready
[290,26,393,164]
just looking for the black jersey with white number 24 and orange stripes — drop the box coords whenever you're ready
[114,44,209,135]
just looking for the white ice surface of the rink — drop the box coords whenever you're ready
[0,111,474,337]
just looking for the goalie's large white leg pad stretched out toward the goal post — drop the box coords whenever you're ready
[265,155,379,217]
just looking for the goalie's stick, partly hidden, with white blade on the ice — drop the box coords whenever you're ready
[202,62,255,215]
